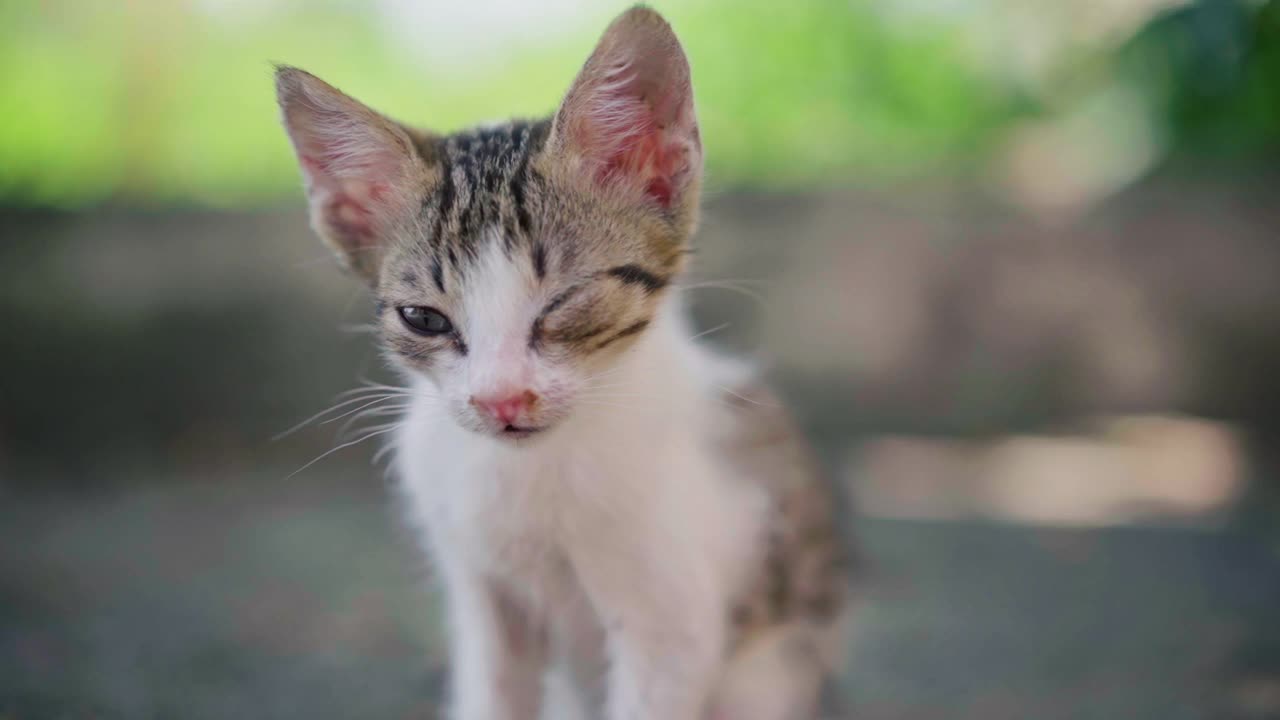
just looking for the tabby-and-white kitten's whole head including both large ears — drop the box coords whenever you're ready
[276,8,701,438]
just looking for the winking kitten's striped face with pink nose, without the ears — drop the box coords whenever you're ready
[376,123,684,438]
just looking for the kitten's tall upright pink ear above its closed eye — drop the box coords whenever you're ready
[550,6,703,210]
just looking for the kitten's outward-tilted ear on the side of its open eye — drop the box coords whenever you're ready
[275,67,429,284]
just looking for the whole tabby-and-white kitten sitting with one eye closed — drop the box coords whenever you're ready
[276,6,846,720]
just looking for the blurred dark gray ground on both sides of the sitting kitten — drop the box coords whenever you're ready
[0,466,1280,720]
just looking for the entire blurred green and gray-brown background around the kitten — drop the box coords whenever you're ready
[0,0,1280,720]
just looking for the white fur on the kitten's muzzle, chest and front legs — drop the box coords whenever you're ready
[397,243,778,720]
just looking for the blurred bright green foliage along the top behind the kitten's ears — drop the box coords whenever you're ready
[0,0,1280,206]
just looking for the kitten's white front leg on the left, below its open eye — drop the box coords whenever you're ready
[447,570,547,720]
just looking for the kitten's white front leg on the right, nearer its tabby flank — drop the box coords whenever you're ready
[579,530,724,720]
